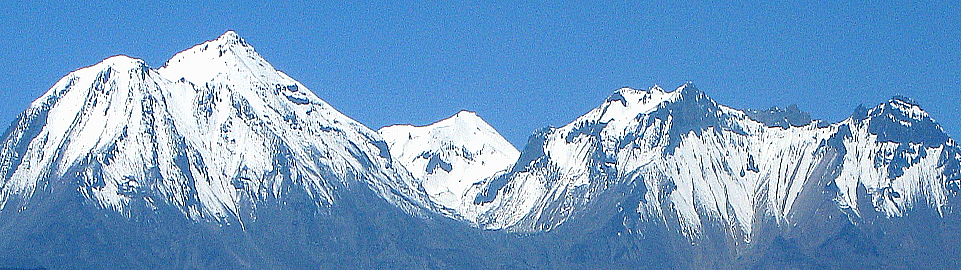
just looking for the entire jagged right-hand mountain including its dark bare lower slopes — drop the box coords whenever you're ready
[434,84,961,268]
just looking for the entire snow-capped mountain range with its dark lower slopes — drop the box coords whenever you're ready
[0,31,961,268]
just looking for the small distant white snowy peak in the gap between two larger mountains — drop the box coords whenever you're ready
[379,111,519,214]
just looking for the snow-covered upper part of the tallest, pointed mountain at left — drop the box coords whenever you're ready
[0,31,429,223]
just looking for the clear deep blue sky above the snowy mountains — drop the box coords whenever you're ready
[0,1,961,147]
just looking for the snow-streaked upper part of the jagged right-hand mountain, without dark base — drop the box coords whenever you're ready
[468,84,961,239]
